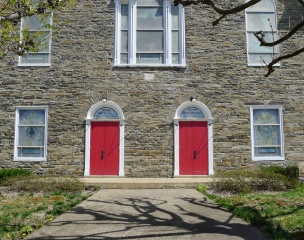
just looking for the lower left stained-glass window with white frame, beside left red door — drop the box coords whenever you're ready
[14,107,47,161]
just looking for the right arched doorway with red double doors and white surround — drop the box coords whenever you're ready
[174,100,213,176]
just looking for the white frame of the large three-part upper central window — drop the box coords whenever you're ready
[114,0,186,67]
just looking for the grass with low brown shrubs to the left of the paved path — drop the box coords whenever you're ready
[0,174,92,240]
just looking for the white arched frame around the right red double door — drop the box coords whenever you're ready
[174,100,214,177]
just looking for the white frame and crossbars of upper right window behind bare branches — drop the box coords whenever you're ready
[245,0,280,66]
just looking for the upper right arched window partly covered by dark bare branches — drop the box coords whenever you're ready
[246,0,279,66]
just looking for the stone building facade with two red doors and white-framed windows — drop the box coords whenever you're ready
[0,0,304,178]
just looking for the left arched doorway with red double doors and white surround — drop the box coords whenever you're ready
[84,101,124,176]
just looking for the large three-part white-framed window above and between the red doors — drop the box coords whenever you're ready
[114,0,185,66]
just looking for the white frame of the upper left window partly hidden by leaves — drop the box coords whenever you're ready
[18,13,53,67]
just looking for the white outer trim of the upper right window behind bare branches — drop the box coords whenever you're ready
[245,0,281,67]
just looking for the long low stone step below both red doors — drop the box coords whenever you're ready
[82,176,213,189]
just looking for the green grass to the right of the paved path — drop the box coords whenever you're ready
[198,183,304,240]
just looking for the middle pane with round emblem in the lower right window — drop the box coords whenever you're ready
[253,125,281,146]
